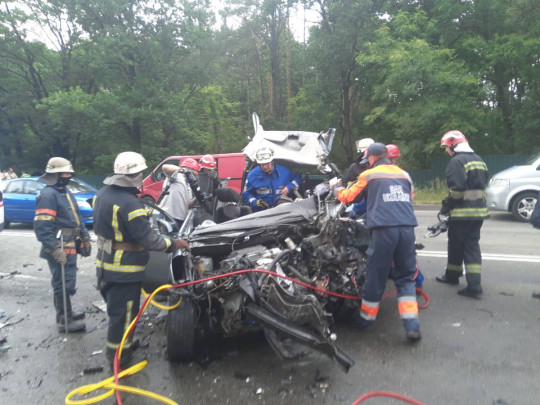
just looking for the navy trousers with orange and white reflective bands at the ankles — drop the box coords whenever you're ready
[360,226,420,330]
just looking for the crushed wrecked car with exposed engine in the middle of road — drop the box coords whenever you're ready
[144,115,369,371]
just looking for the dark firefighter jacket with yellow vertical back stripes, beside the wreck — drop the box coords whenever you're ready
[94,185,175,283]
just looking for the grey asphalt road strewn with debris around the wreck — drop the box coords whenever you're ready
[0,207,540,405]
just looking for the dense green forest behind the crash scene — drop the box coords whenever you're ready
[0,0,540,174]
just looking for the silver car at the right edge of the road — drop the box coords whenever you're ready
[486,153,540,222]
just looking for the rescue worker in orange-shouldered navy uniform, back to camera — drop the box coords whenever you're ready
[332,142,420,341]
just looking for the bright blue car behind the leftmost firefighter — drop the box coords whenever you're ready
[4,177,97,228]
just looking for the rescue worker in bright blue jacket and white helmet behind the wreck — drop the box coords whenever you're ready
[242,146,302,212]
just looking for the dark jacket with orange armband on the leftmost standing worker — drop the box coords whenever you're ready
[34,185,88,260]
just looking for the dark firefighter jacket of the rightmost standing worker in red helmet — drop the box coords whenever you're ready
[443,152,489,221]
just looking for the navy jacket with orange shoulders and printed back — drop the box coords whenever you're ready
[337,159,418,228]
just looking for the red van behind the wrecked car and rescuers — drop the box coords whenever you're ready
[141,153,246,207]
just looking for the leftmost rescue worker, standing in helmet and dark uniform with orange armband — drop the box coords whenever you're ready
[34,157,92,333]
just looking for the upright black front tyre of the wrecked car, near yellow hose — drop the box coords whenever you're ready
[167,294,196,361]
